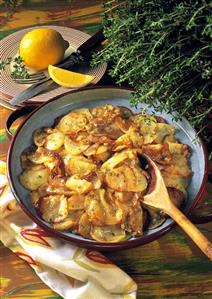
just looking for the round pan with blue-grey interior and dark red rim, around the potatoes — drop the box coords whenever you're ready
[8,87,207,250]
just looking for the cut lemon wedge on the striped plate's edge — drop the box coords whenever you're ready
[48,65,95,88]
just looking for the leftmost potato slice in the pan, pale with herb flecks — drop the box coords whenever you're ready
[20,167,50,190]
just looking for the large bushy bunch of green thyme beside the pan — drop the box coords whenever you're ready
[93,0,212,151]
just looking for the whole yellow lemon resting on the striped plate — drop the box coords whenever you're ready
[19,28,68,71]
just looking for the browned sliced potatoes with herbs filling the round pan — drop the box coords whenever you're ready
[20,105,191,242]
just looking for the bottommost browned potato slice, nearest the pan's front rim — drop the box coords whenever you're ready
[91,225,126,243]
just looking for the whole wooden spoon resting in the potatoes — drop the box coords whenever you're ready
[142,154,212,260]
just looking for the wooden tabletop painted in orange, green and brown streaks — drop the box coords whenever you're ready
[0,0,212,299]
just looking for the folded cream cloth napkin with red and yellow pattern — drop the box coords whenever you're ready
[0,161,137,299]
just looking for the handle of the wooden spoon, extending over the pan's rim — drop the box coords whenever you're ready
[165,204,212,260]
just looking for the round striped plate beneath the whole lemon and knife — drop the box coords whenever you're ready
[0,26,107,103]
